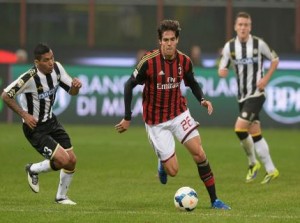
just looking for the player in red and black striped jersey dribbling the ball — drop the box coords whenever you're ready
[115,20,230,209]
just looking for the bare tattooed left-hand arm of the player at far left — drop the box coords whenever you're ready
[1,91,37,129]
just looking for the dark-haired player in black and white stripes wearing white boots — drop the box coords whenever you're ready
[1,43,82,205]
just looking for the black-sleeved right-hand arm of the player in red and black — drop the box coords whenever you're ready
[185,72,213,115]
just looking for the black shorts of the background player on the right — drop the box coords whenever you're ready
[239,95,266,122]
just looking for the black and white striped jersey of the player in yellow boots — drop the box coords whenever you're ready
[219,35,278,102]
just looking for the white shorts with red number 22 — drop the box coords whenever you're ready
[145,110,199,161]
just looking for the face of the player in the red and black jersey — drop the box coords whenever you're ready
[159,30,178,60]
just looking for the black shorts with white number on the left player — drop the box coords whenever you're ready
[23,116,72,159]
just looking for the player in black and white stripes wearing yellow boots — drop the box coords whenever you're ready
[218,12,279,184]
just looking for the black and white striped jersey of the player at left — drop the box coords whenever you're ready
[4,62,72,122]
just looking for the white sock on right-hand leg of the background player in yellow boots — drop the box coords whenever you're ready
[254,138,275,173]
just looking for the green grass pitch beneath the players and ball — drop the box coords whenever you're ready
[0,124,300,223]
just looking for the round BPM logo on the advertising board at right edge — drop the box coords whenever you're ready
[264,75,300,124]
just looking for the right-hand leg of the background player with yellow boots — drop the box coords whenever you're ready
[249,120,279,184]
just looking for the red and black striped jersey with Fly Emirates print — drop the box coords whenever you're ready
[132,49,194,125]
